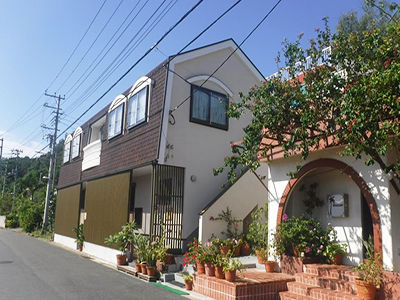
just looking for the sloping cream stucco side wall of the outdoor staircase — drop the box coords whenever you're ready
[199,166,268,242]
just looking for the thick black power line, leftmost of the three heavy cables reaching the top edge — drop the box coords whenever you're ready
[32,0,204,156]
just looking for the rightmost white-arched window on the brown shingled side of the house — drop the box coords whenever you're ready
[128,86,149,127]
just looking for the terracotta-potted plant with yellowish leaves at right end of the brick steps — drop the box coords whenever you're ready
[354,237,384,300]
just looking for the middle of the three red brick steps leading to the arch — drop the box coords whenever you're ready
[296,273,357,295]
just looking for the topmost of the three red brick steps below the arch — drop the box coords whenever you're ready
[303,264,358,282]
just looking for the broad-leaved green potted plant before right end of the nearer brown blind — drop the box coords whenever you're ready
[104,222,136,265]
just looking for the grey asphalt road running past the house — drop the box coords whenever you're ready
[0,229,185,300]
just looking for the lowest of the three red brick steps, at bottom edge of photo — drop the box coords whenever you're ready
[287,281,359,300]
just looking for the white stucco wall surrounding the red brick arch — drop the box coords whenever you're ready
[268,148,400,270]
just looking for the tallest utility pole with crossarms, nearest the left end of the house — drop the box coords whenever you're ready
[42,93,65,232]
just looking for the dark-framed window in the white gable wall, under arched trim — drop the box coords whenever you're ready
[190,85,228,130]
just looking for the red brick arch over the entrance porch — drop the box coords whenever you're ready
[277,158,382,257]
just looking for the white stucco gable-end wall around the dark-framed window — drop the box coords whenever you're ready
[159,42,262,238]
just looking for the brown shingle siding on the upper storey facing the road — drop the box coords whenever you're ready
[59,62,167,188]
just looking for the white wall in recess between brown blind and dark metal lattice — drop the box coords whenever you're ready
[132,175,151,234]
